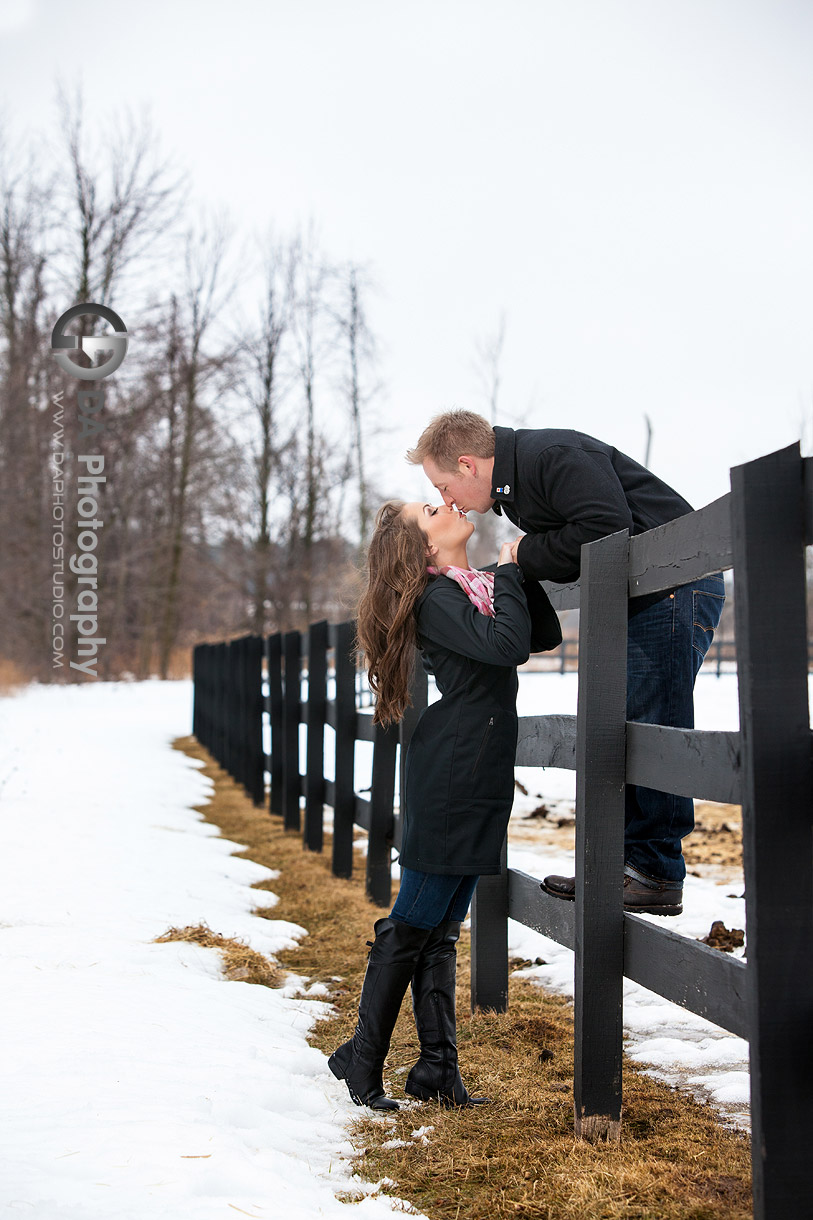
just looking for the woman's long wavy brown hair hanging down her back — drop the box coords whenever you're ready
[356,500,428,725]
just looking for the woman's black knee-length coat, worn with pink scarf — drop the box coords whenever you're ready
[400,564,562,875]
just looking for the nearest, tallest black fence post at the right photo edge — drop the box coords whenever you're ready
[731,443,813,1220]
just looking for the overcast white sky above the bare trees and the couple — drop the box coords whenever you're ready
[0,0,813,506]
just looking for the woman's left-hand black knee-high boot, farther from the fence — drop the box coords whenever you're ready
[327,919,431,1110]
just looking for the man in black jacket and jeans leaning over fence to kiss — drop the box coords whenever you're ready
[407,411,725,915]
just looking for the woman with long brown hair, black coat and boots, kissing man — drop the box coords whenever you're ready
[328,500,562,1110]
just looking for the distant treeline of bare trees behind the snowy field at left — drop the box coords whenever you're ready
[0,88,382,681]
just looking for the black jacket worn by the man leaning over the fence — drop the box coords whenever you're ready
[491,427,692,583]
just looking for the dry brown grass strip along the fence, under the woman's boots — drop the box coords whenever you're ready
[176,738,751,1220]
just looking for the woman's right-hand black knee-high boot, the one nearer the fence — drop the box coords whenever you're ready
[404,921,488,1107]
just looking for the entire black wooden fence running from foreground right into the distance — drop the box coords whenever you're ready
[195,445,813,1220]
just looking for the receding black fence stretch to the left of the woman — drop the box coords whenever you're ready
[193,621,402,906]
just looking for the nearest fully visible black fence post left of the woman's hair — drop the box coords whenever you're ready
[332,622,355,877]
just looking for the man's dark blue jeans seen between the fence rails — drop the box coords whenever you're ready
[624,573,725,881]
